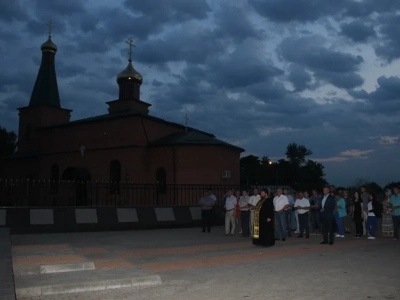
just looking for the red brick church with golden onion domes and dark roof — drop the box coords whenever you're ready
[0,30,244,205]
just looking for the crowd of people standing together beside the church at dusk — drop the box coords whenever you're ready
[200,186,400,246]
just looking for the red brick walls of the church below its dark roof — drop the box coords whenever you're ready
[4,117,240,184]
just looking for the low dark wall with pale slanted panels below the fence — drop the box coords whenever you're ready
[0,206,219,233]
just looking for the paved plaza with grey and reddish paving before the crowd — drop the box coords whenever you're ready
[11,227,400,300]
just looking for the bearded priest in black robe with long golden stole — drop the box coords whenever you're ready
[253,190,275,247]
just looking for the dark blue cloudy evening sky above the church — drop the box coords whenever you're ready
[0,0,400,185]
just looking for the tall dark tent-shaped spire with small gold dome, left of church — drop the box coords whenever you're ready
[29,20,61,108]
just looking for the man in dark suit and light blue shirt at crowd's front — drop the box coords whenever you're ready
[320,187,336,245]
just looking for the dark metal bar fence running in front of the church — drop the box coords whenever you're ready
[0,179,240,206]
